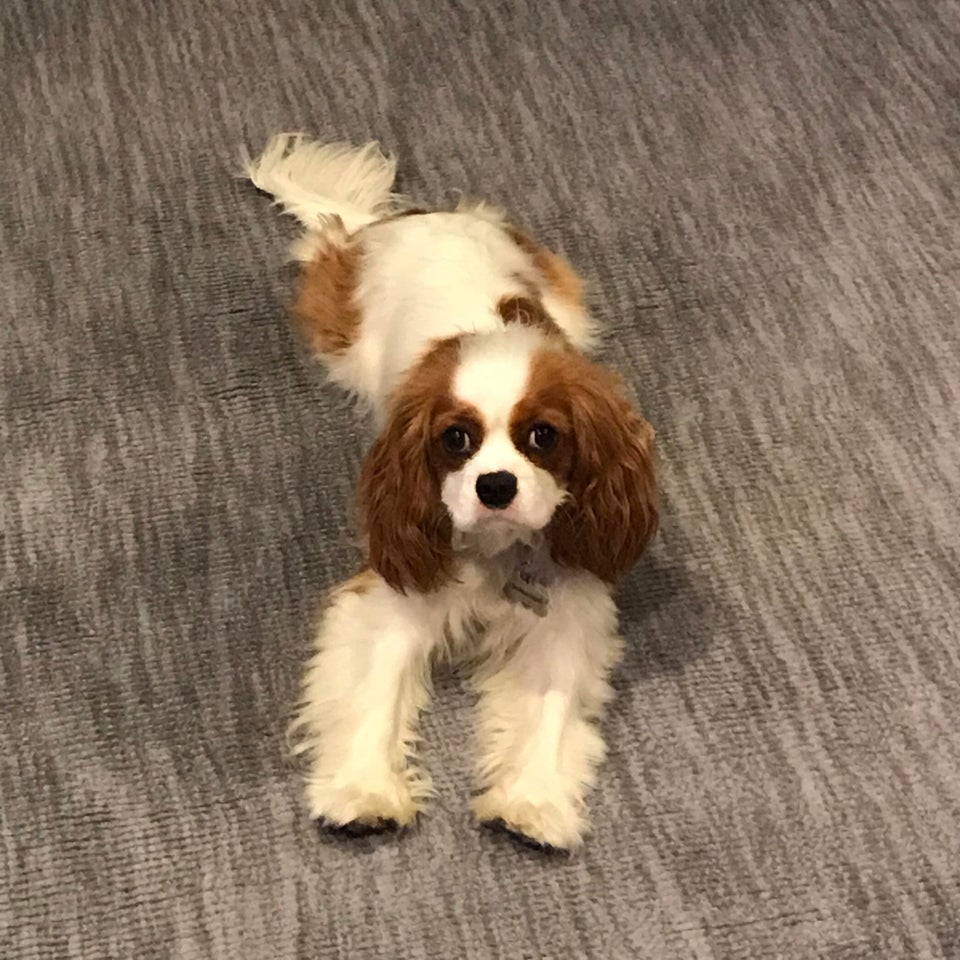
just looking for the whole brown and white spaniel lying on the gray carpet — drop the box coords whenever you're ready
[246,134,658,850]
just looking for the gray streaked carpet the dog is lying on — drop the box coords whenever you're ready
[0,0,960,960]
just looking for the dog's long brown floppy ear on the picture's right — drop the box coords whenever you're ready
[547,362,658,583]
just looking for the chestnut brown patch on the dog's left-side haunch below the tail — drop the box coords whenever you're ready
[291,241,363,356]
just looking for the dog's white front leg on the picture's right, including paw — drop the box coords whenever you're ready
[473,574,621,850]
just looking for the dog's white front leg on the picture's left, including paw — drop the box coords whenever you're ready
[292,571,442,831]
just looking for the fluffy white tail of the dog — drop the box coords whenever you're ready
[244,133,397,233]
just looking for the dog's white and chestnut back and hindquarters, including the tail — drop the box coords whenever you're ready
[247,135,593,415]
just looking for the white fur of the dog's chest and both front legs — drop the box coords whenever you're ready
[295,559,621,849]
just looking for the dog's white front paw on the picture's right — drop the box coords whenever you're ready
[473,786,587,850]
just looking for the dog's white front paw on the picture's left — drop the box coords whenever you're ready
[306,772,425,835]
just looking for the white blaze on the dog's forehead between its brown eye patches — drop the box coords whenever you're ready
[453,324,543,430]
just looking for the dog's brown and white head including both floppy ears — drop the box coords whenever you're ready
[360,325,657,591]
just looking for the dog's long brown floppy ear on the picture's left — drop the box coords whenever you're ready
[358,390,453,593]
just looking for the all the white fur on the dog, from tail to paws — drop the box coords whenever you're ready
[247,134,620,848]
